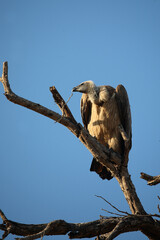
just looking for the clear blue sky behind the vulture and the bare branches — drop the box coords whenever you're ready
[0,0,160,240]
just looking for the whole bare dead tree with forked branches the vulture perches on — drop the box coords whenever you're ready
[0,62,160,240]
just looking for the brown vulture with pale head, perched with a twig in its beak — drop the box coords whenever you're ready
[72,81,132,180]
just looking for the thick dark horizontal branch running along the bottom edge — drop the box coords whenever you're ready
[0,211,160,240]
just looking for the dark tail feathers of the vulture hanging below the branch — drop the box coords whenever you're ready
[90,158,113,180]
